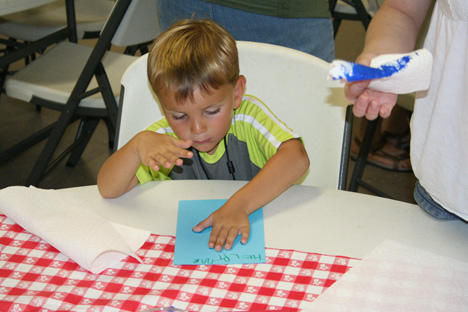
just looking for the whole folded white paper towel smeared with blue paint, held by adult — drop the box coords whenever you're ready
[329,49,432,94]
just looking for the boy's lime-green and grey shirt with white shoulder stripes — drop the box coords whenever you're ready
[136,95,299,184]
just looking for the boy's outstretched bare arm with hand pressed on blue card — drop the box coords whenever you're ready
[193,139,309,251]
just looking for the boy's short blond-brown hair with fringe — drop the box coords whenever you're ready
[148,19,239,103]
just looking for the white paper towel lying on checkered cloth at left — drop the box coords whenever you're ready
[0,186,150,274]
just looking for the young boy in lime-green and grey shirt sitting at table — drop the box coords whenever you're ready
[98,20,309,251]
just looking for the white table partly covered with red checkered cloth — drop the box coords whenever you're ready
[0,181,468,311]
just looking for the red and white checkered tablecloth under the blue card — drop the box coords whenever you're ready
[0,214,359,312]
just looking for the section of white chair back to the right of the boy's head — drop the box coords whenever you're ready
[237,42,351,188]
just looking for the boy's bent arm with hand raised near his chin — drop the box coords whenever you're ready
[97,131,193,198]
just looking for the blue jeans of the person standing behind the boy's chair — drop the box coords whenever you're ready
[158,0,335,62]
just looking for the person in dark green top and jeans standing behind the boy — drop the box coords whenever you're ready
[158,0,335,62]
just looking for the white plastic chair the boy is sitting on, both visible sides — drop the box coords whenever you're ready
[115,41,352,189]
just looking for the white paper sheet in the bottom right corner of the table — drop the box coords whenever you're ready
[310,241,468,312]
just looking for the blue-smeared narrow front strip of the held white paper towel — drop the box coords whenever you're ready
[330,53,418,82]
